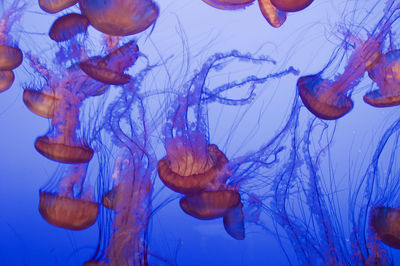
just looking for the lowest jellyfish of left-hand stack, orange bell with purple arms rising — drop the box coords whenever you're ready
[39,164,99,230]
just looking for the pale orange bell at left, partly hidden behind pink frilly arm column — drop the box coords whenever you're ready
[23,89,60,118]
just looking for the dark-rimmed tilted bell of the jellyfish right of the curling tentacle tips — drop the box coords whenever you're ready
[297,74,353,120]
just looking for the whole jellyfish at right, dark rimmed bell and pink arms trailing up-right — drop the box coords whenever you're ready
[297,35,382,120]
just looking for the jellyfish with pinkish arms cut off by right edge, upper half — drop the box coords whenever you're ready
[364,50,400,107]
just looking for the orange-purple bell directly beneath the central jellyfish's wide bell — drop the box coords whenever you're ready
[179,190,240,220]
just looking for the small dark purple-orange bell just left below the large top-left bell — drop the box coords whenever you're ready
[49,13,89,42]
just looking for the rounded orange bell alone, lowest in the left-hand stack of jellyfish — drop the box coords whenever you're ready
[39,192,98,230]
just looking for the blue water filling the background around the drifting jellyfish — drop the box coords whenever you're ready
[0,0,400,265]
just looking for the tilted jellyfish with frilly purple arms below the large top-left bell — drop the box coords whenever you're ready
[79,40,139,85]
